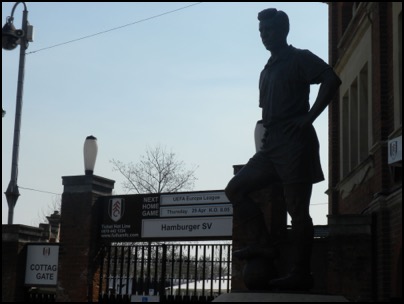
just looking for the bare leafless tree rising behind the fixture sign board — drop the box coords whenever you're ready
[111,145,197,193]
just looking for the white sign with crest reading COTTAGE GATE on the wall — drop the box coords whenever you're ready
[25,244,59,286]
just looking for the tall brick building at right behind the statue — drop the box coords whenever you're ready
[328,2,402,301]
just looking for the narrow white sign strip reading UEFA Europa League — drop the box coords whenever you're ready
[160,192,230,206]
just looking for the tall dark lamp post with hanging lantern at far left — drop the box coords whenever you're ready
[1,2,32,225]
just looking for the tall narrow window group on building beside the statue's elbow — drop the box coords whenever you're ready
[341,63,371,177]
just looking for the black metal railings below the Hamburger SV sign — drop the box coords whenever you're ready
[99,243,232,302]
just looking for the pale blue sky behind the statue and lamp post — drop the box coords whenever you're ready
[2,2,328,226]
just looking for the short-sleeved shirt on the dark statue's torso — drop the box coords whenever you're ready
[259,45,331,127]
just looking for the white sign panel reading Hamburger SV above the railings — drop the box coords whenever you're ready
[142,216,233,238]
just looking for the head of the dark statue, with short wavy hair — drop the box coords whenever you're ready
[258,8,289,51]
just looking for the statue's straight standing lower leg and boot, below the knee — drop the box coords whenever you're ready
[269,219,314,291]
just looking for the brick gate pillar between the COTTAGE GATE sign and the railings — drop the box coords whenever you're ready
[57,175,115,302]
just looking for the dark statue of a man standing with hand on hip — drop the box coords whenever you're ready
[226,8,341,290]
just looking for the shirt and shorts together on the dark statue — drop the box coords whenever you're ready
[252,46,331,184]
